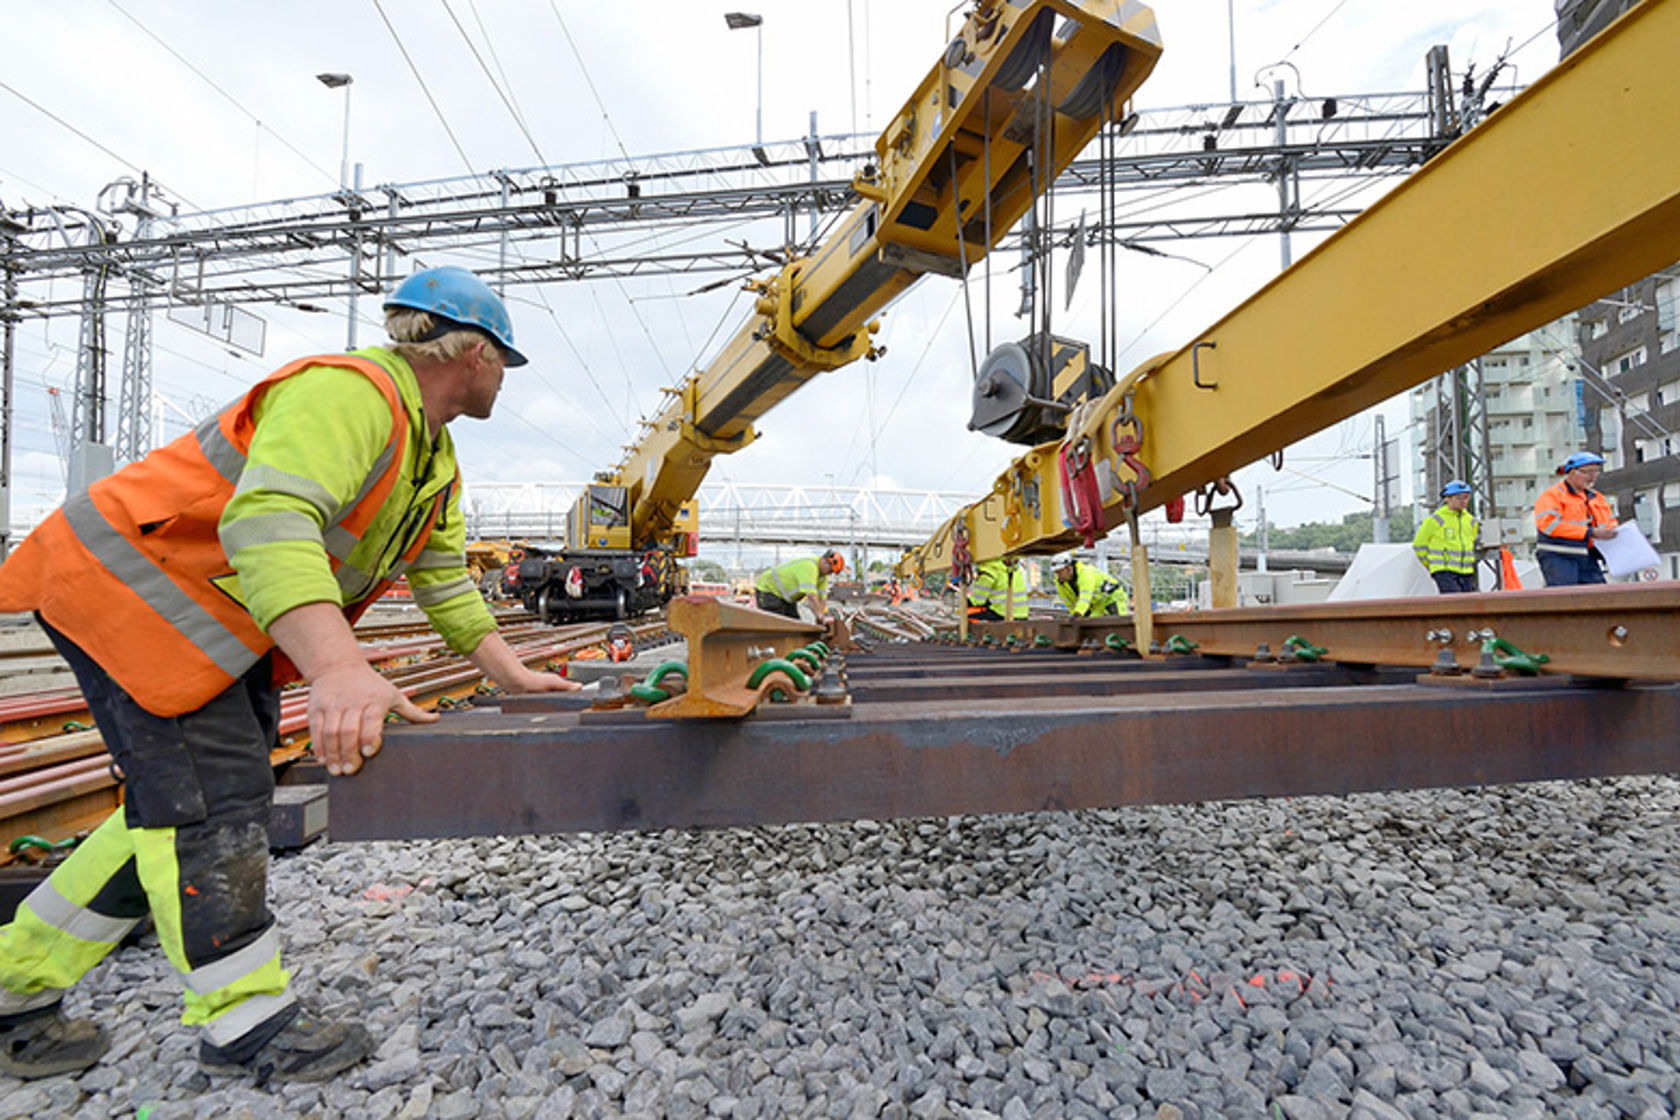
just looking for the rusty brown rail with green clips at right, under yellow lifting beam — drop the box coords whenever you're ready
[971,583,1680,680]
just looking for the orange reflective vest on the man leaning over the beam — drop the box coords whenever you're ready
[0,354,449,715]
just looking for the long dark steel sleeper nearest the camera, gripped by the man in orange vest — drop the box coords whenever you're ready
[329,646,1680,840]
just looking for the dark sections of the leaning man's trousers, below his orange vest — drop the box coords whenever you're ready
[37,616,281,969]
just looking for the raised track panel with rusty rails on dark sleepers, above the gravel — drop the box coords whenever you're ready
[329,583,1680,840]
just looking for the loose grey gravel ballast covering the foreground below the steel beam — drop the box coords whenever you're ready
[0,775,1680,1120]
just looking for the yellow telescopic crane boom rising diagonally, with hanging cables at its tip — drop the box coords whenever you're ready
[584,0,1161,549]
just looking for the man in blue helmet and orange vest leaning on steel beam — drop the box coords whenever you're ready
[0,267,576,1083]
